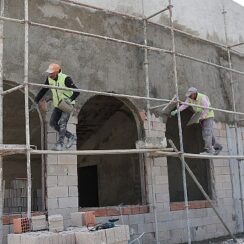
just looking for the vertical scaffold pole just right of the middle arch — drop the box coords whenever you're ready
[143,19,159,244]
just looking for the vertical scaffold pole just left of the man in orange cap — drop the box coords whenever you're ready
[24,0,31,218]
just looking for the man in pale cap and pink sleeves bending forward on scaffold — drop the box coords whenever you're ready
[171,87,223,155]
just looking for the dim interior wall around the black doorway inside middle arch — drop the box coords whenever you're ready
[78,107,141,206]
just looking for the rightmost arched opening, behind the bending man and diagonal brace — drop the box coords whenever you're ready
[166,109,211,202]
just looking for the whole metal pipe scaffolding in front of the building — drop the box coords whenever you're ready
[0,0,244,244]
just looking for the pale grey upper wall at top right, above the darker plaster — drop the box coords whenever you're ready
[76,0,244,50]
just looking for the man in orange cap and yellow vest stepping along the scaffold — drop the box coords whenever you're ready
[30,63,80,151]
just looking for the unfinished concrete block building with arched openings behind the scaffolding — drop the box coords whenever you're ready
[2,0,244,244]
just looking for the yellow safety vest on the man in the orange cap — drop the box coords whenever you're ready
[48,72,75,107]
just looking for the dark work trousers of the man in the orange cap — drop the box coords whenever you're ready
[50,108,73,143]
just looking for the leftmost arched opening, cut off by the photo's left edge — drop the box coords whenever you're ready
[3,82,43,214]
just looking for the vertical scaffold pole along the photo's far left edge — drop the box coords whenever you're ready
[0,0,4,241]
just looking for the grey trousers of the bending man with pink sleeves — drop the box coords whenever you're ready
[200,118,221,150]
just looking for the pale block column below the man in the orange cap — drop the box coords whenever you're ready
[46,111,78,227]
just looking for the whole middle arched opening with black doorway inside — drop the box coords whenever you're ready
[77,96,144,207]
